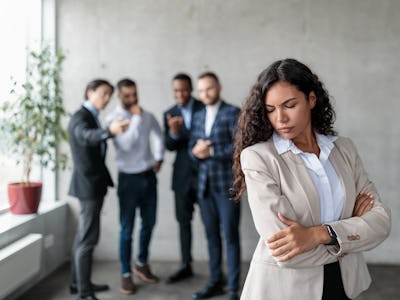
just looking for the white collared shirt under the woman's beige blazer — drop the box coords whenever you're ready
[273,132,344,224]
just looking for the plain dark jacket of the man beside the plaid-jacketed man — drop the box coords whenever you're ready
[164,99,204,193]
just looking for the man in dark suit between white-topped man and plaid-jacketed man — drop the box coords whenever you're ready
[164,73,204,283]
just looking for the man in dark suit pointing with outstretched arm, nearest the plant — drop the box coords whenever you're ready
[68,79,129,300]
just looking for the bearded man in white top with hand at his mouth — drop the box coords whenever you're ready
[107,78,164,294]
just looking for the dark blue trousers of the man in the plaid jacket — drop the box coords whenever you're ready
[199,192,240,292]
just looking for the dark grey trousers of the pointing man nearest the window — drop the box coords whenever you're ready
[71,198,103,297]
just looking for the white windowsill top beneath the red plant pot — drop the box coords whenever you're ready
[0,201,66,235]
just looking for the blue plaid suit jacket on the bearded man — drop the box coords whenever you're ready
[189,101,240,197]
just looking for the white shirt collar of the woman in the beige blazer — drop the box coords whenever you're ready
[272,131,337,155]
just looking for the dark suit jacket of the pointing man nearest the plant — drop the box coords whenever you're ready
[68,106,113,199]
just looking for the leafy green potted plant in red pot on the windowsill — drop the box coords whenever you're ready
[0,46,67,214]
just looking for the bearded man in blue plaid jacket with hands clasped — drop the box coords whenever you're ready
[189,72,240,300]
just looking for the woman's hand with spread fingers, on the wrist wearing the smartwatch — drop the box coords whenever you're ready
[267,213,330,262]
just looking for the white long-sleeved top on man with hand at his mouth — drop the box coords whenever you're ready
[106,106,164,174]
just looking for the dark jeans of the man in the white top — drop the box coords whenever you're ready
[118,171,157,274]
